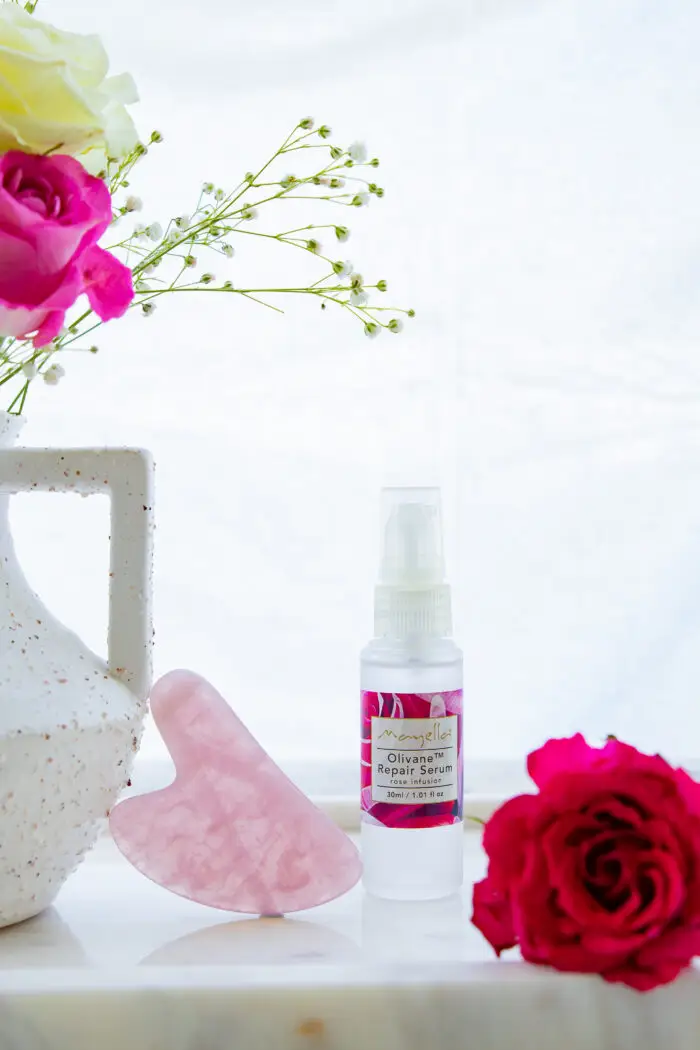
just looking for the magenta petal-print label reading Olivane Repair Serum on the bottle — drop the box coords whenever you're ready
[362,689,464,827]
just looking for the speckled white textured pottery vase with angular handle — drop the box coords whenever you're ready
[0,413,153,926]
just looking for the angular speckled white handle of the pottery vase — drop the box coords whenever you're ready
[0,448,153,699]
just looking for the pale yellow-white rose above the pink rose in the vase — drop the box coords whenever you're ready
[0,3,139,171]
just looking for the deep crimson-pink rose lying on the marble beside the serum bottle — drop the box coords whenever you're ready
[472,734,700,991]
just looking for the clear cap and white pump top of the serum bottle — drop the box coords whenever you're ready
[375,488,452,637]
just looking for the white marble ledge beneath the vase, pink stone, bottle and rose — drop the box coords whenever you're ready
[0,833,700,1050]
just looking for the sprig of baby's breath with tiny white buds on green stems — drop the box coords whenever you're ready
[0,117,415,414]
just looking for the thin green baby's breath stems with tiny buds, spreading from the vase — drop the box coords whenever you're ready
[0,120,415,413]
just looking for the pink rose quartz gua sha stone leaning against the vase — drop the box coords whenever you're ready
[109,671,362,916]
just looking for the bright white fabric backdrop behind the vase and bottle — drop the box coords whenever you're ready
[9,0,700,772]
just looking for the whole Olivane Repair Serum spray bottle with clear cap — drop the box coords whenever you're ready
[361,488,464,901]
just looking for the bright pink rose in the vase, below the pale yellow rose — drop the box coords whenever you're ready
[0,151,133,347]
